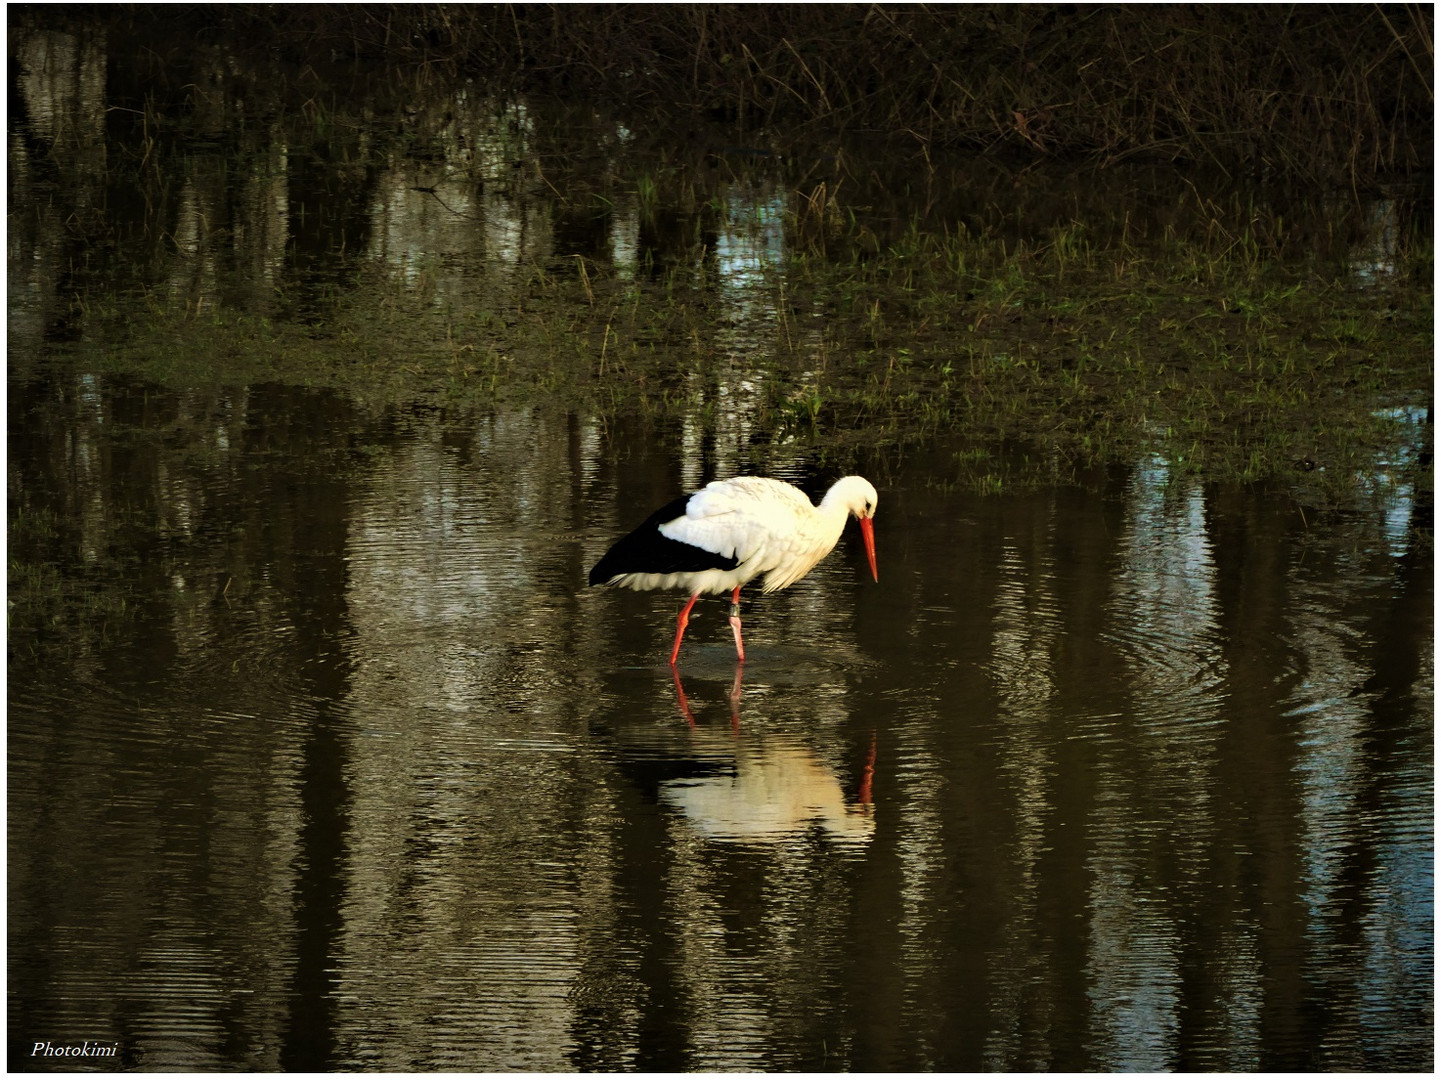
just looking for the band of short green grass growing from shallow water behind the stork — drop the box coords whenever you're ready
[73,224,1432,501]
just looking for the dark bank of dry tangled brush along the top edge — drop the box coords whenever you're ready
[10,4,1434,189]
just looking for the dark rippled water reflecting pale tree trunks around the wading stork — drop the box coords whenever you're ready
[7,12,1434,1071]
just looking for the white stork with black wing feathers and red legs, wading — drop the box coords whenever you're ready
[589,476,880,668]
